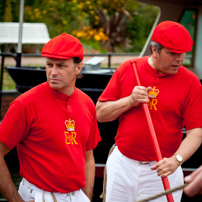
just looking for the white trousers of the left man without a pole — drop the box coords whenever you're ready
[18,178,90,202]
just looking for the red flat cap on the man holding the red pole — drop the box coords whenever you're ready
[152,21,193,53]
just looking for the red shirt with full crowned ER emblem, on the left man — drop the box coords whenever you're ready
[0,82,101,193]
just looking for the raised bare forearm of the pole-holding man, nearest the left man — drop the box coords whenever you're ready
[96,97,132,122]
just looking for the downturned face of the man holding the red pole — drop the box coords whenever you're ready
[153,47,185,74]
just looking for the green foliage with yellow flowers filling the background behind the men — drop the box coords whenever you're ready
[0,0,158,52]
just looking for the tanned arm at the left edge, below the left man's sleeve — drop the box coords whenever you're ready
[0,157,23,202]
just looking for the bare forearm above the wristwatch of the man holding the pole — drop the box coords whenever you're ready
[176,128,202,162]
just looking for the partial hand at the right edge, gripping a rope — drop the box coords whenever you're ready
[184,166,202,196]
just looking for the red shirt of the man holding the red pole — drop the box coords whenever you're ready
[98,57,202,161]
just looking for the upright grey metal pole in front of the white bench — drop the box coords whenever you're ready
[16,0,24,67]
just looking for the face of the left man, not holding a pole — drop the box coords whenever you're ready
[46,58,82,95]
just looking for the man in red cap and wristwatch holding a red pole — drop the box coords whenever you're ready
[96,21,202,202]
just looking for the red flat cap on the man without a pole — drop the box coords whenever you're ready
[41,33,83,60]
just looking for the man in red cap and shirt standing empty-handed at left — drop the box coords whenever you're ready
[0,33,101,202]
